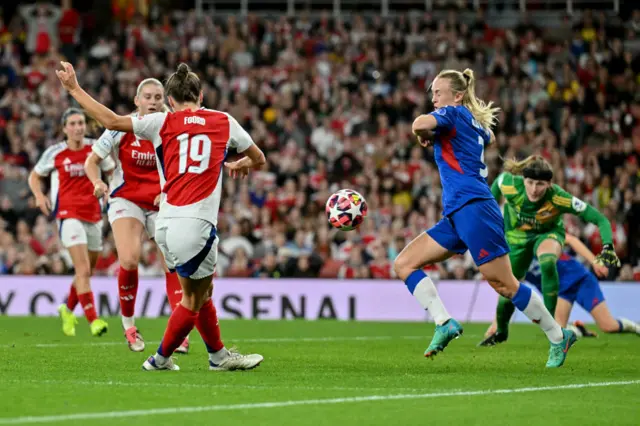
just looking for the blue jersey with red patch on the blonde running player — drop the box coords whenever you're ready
[430,106,493,216]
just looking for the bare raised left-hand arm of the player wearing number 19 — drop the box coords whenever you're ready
[56,61,133,132]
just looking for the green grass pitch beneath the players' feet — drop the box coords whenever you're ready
[0,317,640,426]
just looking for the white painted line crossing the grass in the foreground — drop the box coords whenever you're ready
[0,380,640,425]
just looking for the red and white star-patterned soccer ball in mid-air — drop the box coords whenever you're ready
[325,189,368,231]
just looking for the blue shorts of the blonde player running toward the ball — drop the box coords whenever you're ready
[427,199,509,266]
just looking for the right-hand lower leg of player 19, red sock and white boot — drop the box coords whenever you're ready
[196,298,264,371]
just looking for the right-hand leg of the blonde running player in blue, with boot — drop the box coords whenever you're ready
[479,255,576,368]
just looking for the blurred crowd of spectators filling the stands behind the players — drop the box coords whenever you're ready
[0,0,640,281]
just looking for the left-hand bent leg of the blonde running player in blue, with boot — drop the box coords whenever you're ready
[393,231,463,358]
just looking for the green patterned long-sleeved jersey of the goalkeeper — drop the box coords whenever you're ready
[491,172,612,244]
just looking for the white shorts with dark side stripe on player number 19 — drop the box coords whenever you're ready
[156,217,218,280]
